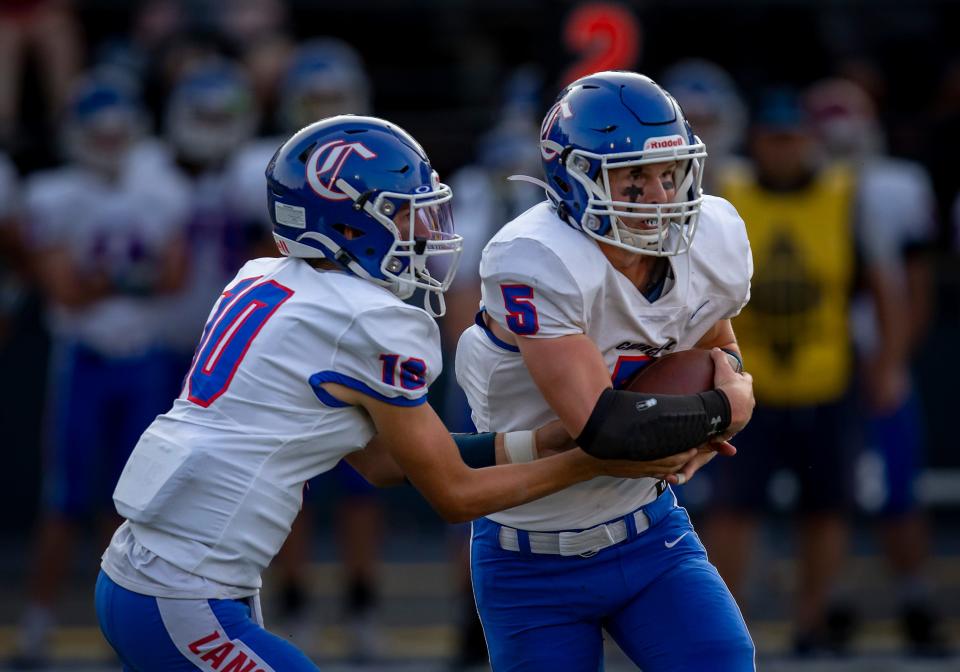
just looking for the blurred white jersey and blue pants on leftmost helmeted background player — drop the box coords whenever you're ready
[24,167,184,517]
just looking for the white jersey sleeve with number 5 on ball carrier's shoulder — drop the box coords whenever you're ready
[480,238,587,338]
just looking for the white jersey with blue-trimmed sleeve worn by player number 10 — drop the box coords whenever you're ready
[104,258,441,597]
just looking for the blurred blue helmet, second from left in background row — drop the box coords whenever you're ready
[166,60,257,165]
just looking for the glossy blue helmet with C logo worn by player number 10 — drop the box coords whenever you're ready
[266,115,463,316]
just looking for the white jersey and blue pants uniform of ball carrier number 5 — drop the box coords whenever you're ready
[456,196,753,672]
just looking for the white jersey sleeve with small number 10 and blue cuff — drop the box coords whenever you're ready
[318,306,443,406]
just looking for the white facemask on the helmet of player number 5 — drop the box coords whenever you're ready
[563,138,707,257]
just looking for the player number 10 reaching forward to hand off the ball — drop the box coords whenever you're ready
[96,116,747,672]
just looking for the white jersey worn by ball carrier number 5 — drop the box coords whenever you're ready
[456,196,753,531]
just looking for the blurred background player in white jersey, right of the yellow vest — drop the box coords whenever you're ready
[807,79,945,654]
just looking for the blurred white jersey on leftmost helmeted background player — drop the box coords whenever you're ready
[24,158,187,357]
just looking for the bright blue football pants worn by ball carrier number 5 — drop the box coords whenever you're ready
[471,489,755,672]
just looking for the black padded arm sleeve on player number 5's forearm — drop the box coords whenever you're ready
[577,388,730,461]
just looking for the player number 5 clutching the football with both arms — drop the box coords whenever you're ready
[456,72,754,672]
